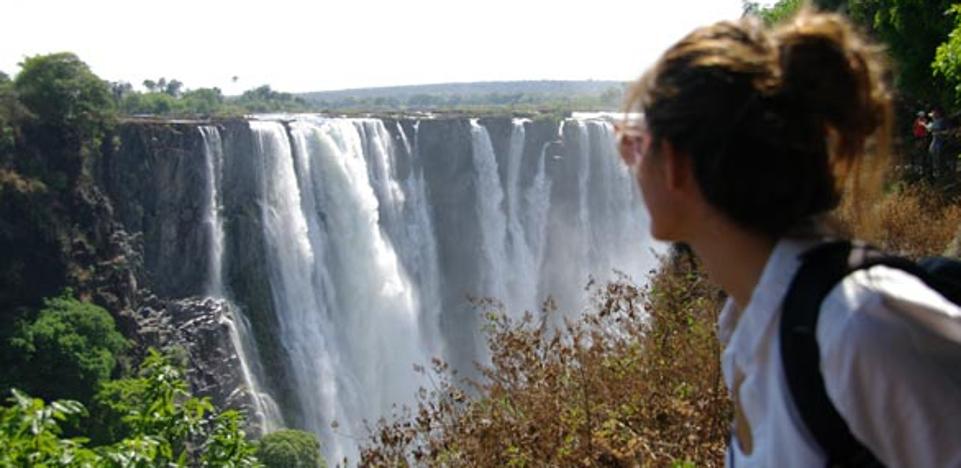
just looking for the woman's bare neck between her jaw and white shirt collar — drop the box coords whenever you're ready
[690,218,775,310]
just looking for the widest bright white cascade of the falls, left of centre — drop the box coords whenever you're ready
[251,117,431,459]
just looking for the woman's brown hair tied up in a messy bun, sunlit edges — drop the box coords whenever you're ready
[627,9,892,237]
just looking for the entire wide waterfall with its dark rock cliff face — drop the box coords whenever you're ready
[105,115,655,459]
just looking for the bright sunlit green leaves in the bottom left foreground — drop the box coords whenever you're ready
[0,351,261,467]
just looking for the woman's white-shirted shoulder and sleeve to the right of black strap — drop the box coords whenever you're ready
[817,266,961,466]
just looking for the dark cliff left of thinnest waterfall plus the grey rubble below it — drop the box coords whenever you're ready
[96,122,269,420]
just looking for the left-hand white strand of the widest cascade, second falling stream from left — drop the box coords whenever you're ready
[250,121,348,458]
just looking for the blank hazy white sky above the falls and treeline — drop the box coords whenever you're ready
[0,0,741,94]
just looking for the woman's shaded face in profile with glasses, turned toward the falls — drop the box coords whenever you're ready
[617,124,682,241]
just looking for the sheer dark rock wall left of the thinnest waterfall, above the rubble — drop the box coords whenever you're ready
[101,123,210,297]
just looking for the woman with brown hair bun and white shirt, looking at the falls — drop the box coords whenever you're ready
[620,8,961,467]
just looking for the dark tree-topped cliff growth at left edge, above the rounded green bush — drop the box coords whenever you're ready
[0,54,115,330]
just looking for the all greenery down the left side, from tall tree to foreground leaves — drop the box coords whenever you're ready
[0,53,324,467]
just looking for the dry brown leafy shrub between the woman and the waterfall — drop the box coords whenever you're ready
[360,254,731,467]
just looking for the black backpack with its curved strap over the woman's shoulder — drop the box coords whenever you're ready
[780,241,961,467]
